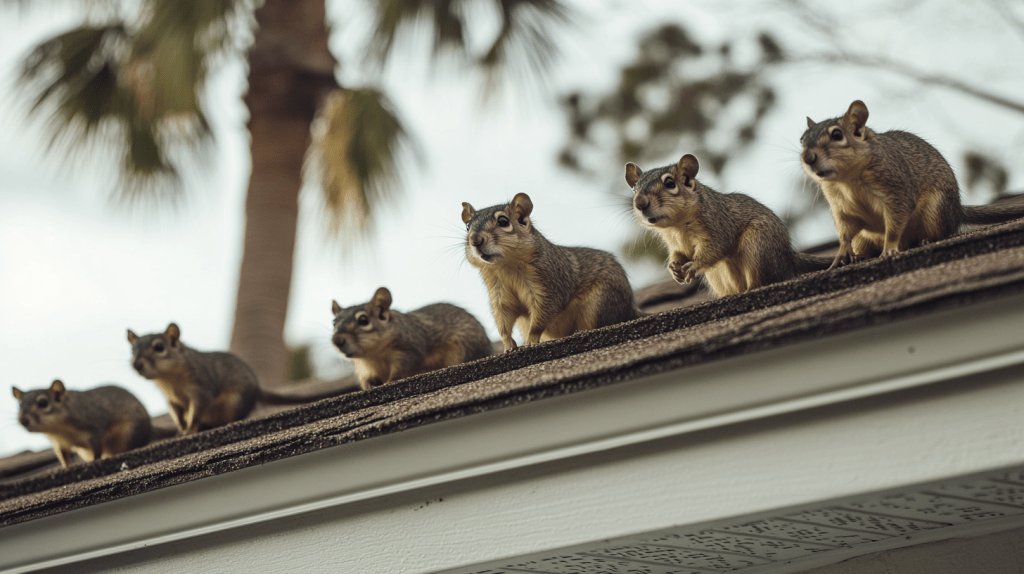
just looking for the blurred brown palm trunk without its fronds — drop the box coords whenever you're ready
[230,0,337,387]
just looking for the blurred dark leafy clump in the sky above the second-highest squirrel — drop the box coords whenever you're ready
[559,24,783,179]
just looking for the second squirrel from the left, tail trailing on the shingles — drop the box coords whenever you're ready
[128,323,335,435]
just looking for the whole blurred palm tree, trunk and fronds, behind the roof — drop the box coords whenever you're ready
[16,0,568,386]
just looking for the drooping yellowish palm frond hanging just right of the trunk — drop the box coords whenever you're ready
[306,88,418,238]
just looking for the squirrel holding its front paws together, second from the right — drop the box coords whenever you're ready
[626,153,831,297]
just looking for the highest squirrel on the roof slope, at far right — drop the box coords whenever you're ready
[800,99,1024,268]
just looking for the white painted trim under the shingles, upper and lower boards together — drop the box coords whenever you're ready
[0,296,1024,572]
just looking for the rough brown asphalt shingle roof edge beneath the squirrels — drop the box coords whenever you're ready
[0,215,1024,527]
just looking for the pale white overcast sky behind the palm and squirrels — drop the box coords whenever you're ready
[0,0,1024,456]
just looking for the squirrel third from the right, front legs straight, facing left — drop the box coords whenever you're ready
[462,193,641,352]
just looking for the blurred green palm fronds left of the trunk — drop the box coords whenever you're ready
[20,0,252,195]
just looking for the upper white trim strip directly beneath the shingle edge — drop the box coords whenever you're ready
[6,296,1024,572]
